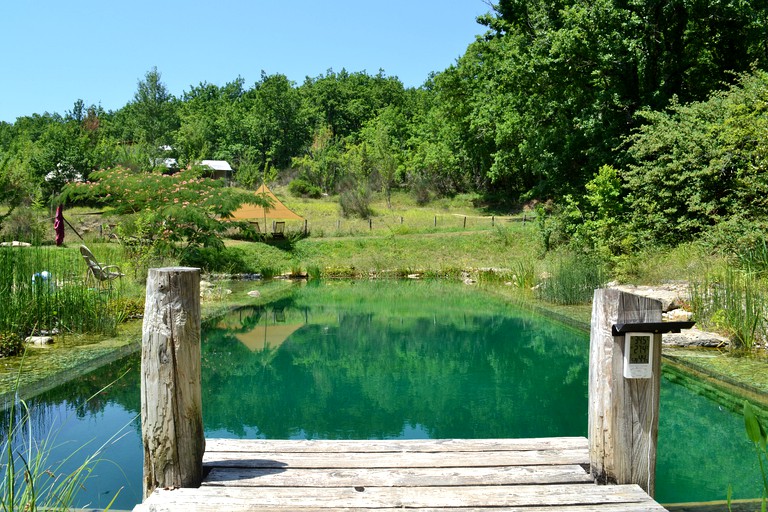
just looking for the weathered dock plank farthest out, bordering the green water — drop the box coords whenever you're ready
[201,437,588,453]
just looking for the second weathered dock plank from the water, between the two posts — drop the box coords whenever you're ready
[204,449,588,468]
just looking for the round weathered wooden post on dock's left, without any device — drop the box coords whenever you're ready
[141,267,205,498]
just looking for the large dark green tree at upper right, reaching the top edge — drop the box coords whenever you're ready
[434,0,768,202]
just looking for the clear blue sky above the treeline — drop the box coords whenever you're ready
[0,0,490,122]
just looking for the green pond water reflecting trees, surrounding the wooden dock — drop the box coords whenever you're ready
[3,281,759,509]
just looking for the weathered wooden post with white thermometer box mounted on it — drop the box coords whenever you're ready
[589,289,661,496]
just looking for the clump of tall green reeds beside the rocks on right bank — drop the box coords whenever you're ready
[691,268,768,350]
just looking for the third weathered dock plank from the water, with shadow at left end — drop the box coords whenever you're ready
[203,466,593,487]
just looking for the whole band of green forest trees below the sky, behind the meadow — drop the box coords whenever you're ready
[0,0,768,255]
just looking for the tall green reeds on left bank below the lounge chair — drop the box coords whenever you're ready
[0,247,119,336]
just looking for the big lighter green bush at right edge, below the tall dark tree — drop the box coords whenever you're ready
[625,71,768,245]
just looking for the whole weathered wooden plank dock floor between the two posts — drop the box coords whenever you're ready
[134,437,665,512]
